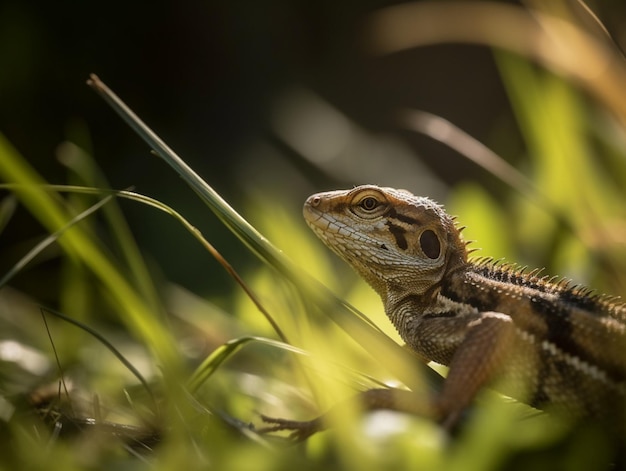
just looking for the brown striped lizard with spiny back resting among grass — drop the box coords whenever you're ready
[263,185,626,440]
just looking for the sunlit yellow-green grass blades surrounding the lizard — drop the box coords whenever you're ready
[0,1,626,470]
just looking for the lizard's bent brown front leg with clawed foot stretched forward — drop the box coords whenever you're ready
[258,312,515,441]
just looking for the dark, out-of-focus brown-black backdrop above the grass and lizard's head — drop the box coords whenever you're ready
[0,0,626,298]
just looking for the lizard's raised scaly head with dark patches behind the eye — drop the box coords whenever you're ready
[303,185,467,299]
